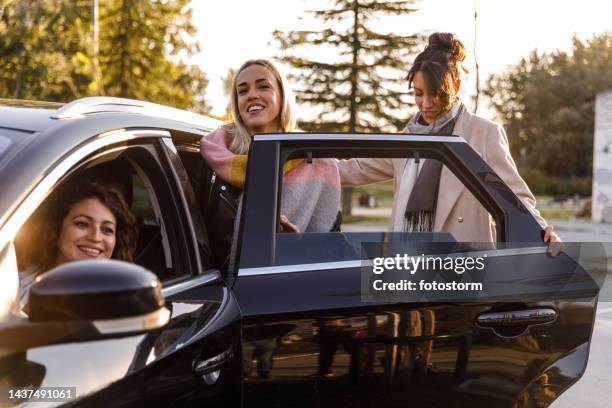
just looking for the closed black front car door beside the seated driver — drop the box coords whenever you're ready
[3,129,241,406]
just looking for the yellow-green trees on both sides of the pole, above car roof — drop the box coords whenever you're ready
[0,0,208,111]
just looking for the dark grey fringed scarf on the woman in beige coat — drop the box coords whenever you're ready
[403,102,464,232]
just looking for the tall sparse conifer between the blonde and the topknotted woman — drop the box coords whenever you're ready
[274,0,422,131]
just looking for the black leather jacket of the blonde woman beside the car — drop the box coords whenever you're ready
[192,160,242,271]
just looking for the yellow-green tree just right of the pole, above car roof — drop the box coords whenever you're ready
[100,0,208,112]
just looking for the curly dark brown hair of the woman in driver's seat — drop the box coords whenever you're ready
[20,179,138,271]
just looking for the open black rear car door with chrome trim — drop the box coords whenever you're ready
[234,135,602,407]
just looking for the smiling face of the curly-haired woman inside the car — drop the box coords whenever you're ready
[56,198,117,265]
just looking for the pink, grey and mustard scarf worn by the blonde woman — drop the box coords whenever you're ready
[200,126,340,232]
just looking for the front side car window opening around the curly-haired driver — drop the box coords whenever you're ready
[15,146,190,283]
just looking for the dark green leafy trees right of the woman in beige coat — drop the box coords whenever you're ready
[485,33,612,181]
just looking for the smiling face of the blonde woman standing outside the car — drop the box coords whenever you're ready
[236,64,283,133]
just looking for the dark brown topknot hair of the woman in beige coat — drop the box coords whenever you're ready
[408,33,468,112]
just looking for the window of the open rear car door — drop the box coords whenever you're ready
[274,158,495,266]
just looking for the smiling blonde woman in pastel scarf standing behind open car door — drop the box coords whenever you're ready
[194,59,340,269]
